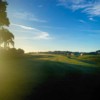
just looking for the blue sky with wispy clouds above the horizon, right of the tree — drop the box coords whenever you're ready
[7,0,100,52]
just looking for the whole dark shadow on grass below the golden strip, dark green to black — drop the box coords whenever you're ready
[24,57,100,100]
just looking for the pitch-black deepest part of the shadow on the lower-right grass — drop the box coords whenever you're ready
[26,73,100,100]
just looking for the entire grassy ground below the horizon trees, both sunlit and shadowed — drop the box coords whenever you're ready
[0,54,100,100]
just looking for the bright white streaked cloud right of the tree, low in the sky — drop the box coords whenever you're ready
[10,24,52,40]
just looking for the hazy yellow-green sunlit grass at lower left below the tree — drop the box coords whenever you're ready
[0,59,43,100]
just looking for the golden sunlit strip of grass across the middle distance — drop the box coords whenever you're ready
[33,55,94,67]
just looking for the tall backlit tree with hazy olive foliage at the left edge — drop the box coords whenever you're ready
[0,0,14,48]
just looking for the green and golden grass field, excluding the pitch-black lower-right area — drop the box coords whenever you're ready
[0,54,100,100]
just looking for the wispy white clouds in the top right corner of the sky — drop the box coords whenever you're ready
[58,0,100,16]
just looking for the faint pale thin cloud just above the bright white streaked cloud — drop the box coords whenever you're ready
[12,12,47,23]
